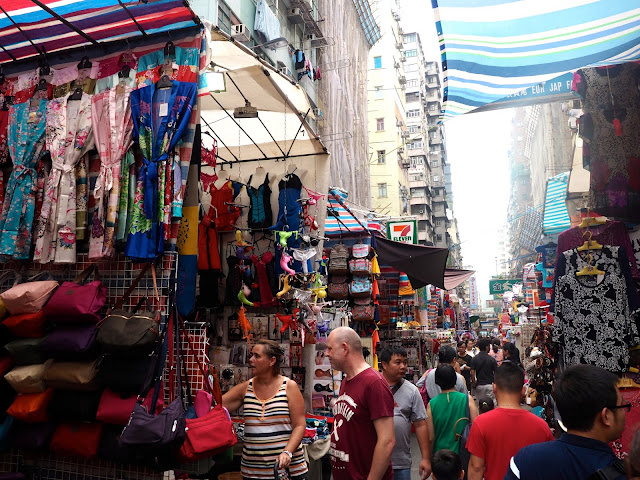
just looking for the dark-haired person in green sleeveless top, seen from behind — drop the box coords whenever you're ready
[427,364,478,453]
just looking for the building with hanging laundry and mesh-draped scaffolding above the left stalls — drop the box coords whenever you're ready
[190,0,380,206]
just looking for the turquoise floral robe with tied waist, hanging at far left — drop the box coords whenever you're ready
[0,99,47,260]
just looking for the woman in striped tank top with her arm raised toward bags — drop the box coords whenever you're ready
[222,340,307,480]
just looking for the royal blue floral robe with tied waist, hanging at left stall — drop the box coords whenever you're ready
[125,81,197,260]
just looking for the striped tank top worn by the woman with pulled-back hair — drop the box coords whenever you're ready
[240,377,307,480]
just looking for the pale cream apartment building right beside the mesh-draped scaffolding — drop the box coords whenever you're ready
[367,0,410,217]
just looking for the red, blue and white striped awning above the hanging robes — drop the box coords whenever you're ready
[0,0,199,63]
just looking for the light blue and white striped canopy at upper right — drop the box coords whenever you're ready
[432,0,640,119]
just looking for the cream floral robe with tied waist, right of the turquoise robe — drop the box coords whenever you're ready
[34,93,94,263]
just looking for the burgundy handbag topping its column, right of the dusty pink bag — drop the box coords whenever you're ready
[43,263,107,323]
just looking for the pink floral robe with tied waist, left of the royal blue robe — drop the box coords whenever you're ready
[89,87,133,258]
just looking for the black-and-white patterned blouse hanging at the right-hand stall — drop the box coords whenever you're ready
[554,245,640,373]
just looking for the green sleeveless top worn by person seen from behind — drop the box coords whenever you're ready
[429,392,469,453]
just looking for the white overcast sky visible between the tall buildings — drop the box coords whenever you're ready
[401,0,513,304]
